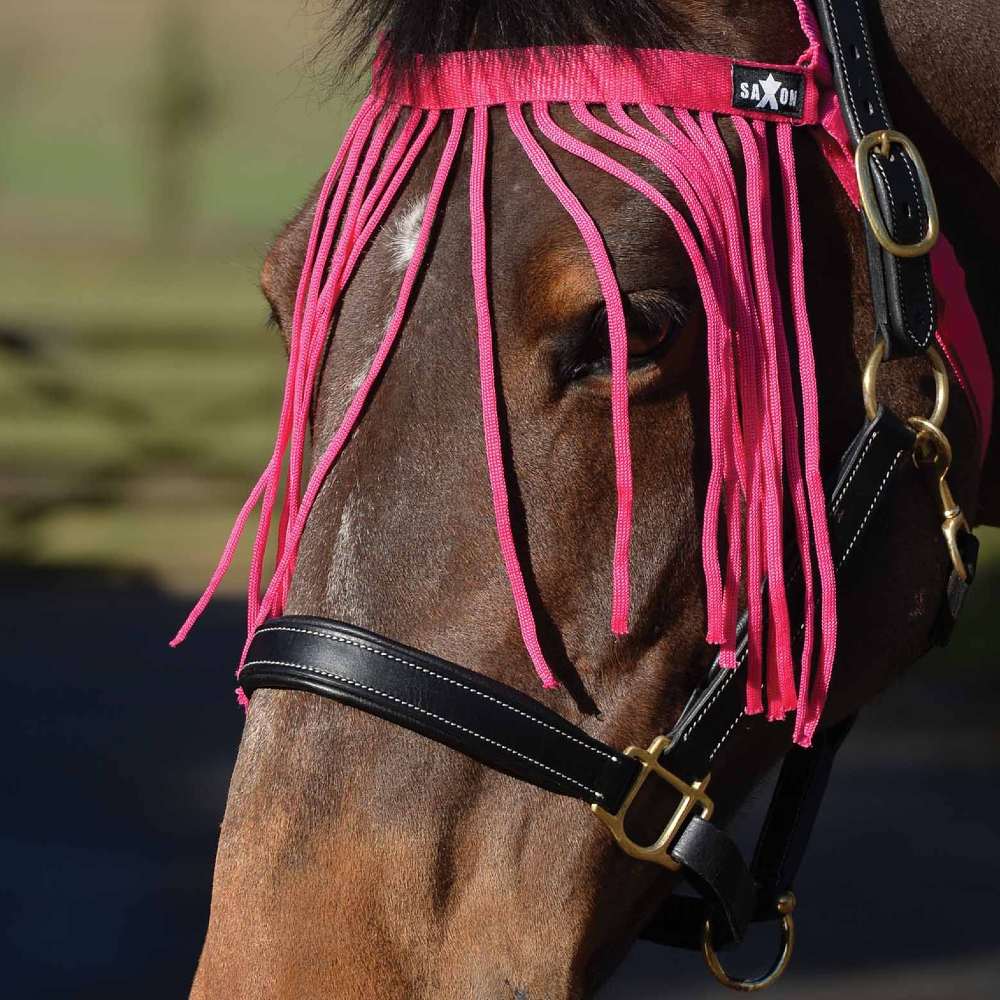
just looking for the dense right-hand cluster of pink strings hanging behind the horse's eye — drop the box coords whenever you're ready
[515,102,837,745]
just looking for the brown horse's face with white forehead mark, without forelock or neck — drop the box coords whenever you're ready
[189,13,976,1000]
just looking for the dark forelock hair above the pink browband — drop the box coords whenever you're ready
[322,0,685,76]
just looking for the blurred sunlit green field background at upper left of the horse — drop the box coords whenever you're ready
[0,0,353,592]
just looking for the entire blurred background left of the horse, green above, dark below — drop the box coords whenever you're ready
[0,7,364,1000]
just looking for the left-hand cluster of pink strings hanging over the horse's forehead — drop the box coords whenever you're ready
[171,97,450,645]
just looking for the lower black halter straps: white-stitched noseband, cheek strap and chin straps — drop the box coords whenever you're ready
[240,410,913,947]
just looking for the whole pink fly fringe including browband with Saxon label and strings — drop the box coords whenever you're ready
[174,0,984,746]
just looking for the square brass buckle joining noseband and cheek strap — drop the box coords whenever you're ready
[590,736,715,872]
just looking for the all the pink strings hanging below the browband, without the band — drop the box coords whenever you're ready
[174,97,837,746]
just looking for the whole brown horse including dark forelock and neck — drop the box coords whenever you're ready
[184,0,1000,1000]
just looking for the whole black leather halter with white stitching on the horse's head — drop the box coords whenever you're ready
[240,0,975,989]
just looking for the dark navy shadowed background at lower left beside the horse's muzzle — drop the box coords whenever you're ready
[0,570,245,1000]
